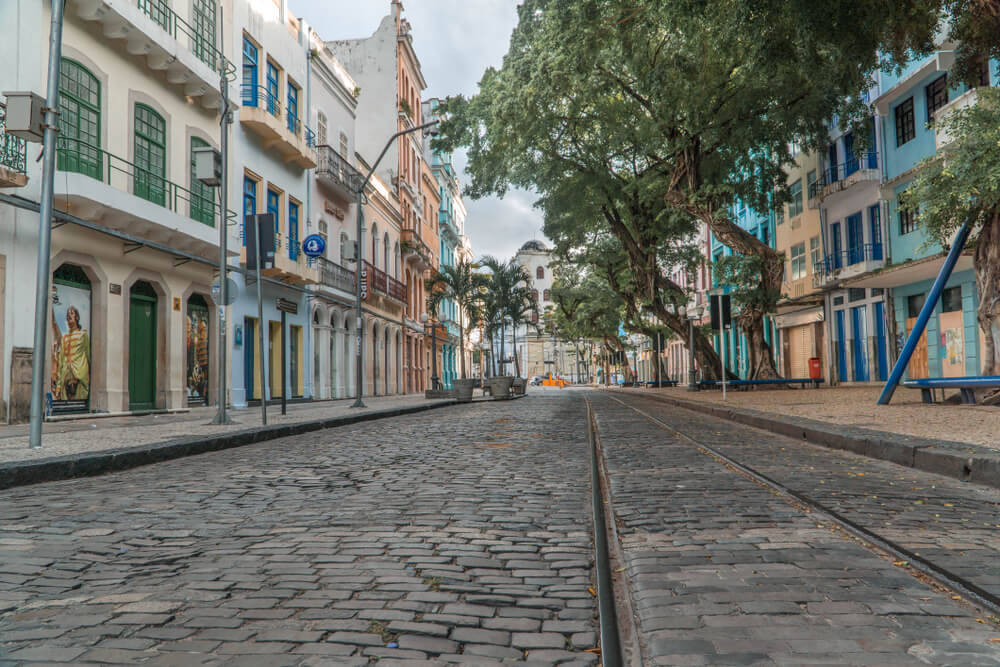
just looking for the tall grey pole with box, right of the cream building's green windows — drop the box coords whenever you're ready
[211,10,234,424]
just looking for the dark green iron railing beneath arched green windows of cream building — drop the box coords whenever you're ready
[56,136,236,227]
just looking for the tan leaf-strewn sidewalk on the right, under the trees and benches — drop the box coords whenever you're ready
[625,386,1000,451]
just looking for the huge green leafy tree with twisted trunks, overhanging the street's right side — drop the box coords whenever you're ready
[441,0,952,377]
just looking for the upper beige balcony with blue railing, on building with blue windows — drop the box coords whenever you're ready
[240,84,317,169]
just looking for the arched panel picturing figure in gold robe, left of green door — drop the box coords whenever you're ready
[49,264,90,412]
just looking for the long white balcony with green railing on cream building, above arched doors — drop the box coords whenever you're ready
[54,137,236,259]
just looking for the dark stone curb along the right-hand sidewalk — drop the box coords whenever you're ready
[616,394,1000,489]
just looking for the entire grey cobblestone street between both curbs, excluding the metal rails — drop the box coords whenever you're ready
[0,390,1000,665]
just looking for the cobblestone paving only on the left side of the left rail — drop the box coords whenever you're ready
[0,397,597,665]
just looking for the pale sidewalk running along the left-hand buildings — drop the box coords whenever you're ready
[0,394,441,463]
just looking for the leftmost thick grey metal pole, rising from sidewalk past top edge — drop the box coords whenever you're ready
[28,0,64,449]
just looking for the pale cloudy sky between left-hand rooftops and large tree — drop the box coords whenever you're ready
[288,0,551,258]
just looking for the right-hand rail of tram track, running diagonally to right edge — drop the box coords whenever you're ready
[600,394,1000,625]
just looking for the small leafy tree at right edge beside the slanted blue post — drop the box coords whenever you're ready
[903,88,1000,375]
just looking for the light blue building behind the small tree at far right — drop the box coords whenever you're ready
[838,47,996,379]
